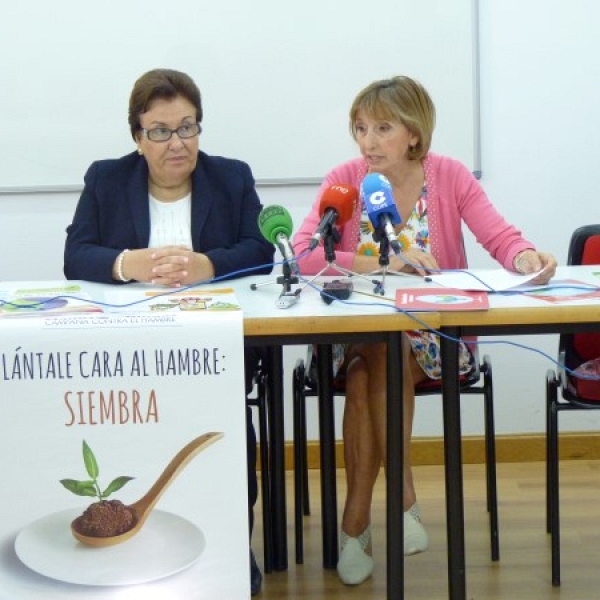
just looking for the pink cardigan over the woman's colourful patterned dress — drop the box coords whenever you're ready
[293,153,535,275]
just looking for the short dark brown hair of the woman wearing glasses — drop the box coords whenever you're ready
[128,69,202,140]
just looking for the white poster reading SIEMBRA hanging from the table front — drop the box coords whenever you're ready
[0,290,250,600]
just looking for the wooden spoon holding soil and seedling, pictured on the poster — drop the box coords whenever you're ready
[71,432,223,548]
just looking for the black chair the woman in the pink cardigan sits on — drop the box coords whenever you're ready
[293,350,500,564]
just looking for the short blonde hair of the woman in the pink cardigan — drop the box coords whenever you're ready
[350,75,435,160]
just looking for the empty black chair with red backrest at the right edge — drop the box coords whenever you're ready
[546,225,600,586]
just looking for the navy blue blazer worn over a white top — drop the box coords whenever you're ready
[64,152,275,283]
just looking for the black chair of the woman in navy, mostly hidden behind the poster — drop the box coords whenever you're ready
[246,360,273,573]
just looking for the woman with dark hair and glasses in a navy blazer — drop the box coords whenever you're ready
[64,69,275,594]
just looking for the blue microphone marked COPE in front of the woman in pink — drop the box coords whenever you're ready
[360,173,402,254]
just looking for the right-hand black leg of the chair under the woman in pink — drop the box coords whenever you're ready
[481,357,500,561]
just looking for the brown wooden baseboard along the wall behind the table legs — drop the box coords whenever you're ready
[276,432,600,469]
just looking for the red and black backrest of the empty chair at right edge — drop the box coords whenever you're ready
[559,224,600,396]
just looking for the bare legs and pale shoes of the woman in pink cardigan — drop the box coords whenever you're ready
[337,338,429,585]
